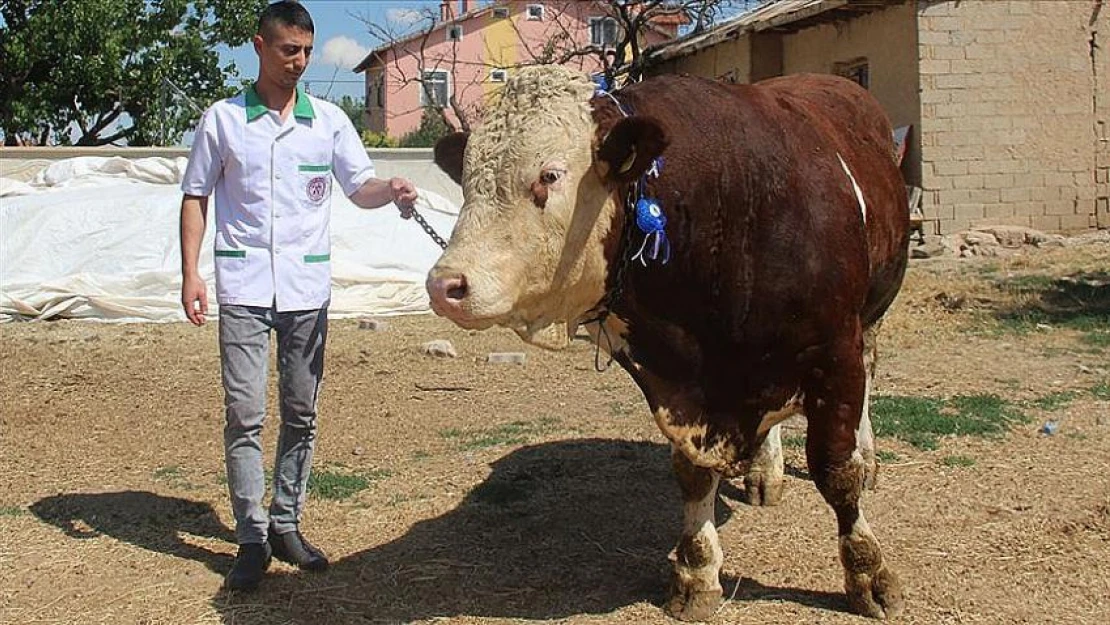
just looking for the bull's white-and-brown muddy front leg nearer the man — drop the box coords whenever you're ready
[667,450,725,621]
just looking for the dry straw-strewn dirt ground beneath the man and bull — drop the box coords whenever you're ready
[0,243,1110,624]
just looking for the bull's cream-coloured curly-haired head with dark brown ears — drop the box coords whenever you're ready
[427,65,665,346]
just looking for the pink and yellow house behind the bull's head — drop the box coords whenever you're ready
[354,0,686,138]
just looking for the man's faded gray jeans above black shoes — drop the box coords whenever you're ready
[220,305,327,544]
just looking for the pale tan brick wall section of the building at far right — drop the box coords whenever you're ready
[917,0,1110,233]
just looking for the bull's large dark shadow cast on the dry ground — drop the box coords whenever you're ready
[227,440,842,624]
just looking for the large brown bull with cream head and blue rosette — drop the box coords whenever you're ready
[427,67,909,619]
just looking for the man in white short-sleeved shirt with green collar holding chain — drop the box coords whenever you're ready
[181,0,416,589]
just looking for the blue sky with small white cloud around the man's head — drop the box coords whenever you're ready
[220,0,455,99]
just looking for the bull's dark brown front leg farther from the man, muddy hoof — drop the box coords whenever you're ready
[806,327,902,618]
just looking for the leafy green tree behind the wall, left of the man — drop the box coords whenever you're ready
[0,0,268,145]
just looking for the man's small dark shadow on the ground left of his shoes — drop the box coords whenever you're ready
[30,491,235,575]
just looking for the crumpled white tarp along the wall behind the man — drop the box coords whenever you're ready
[0,157,458,321]
